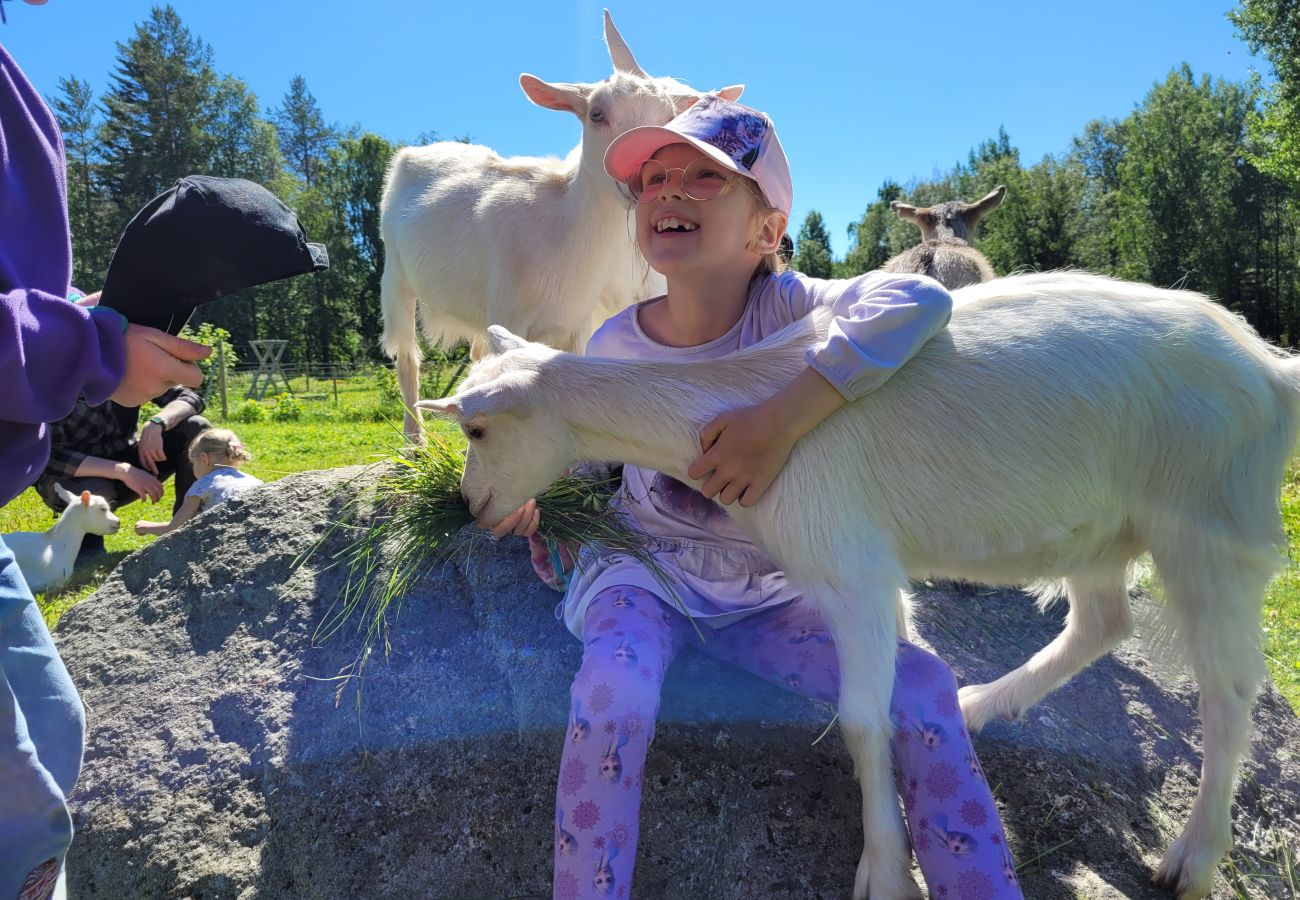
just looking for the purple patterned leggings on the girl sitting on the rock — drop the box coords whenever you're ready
[554,585,1022,900]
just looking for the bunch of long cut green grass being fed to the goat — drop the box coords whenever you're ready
[299,430,680,674]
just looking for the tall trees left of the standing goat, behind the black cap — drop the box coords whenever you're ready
[51,5,395,363]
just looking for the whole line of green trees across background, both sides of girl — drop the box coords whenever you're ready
[51,0,1300,363]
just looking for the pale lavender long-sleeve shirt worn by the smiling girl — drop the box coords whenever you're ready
[556,272,953,637]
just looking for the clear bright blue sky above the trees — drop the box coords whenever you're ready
[0,0,1264,256]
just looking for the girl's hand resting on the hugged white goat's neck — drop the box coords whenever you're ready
[686,404,800,506]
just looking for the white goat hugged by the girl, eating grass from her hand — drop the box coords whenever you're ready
[421,273,1300,900]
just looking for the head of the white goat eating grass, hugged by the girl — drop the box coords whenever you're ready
[416,325,576,527]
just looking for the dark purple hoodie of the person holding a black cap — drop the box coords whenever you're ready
[0,46,126,506]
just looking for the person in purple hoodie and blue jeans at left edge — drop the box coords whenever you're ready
[0,15,211,900]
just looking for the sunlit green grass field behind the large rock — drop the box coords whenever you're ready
[0,376,1300,710]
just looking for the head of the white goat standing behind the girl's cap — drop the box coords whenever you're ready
[519,10,745,190]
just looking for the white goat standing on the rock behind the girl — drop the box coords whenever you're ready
[380,12,744,440]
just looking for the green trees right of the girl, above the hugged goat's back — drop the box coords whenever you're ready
[792,0,1300,346]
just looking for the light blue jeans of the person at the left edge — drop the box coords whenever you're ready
[0,540,86,900]
